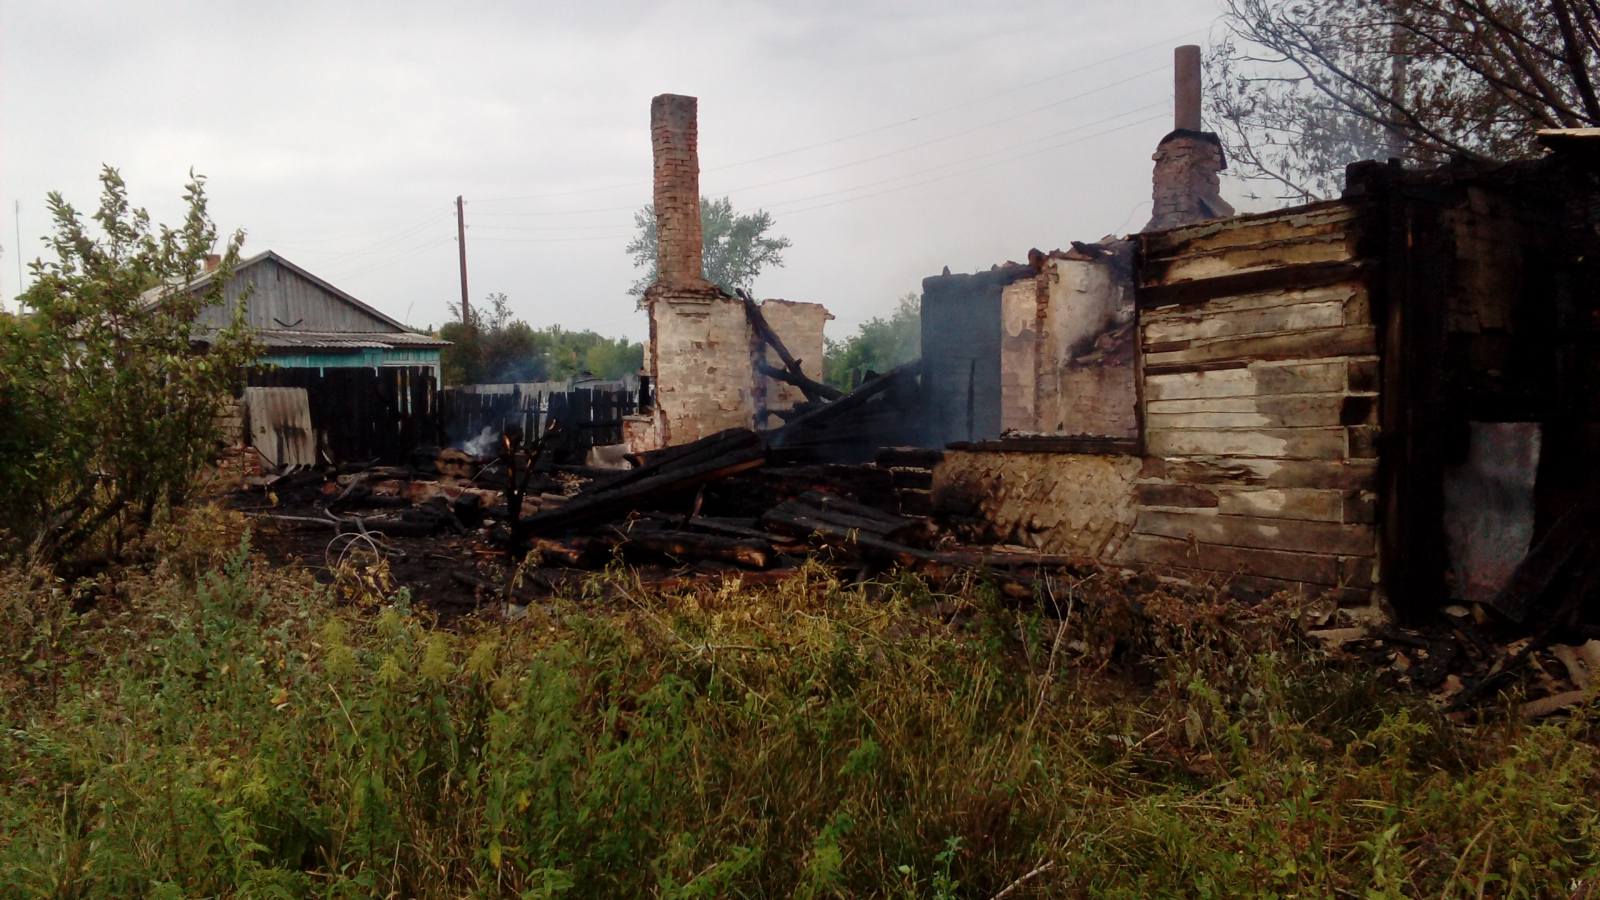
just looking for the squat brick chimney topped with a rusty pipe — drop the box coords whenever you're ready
[1144,43,1234,231]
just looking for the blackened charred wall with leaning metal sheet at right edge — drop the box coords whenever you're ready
[1347,157,1600,615]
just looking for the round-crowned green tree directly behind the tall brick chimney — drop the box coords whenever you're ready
[627,197,790,296]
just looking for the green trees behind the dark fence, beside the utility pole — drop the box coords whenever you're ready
[440,293,645,384]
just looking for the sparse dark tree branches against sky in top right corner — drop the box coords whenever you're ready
[1206,0,1600,202]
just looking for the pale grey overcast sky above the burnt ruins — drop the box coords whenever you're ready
[0,0,1218,338]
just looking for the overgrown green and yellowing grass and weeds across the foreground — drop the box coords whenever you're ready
[0,509,1600,897]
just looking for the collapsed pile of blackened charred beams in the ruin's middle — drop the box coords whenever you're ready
[236,371,1088,597]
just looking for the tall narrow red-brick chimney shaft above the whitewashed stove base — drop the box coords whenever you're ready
[650,94,710,290]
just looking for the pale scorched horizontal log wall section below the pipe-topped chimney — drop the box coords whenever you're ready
[1120,202,1378,602]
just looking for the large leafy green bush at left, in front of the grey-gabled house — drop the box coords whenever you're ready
[0,167,258,564]
